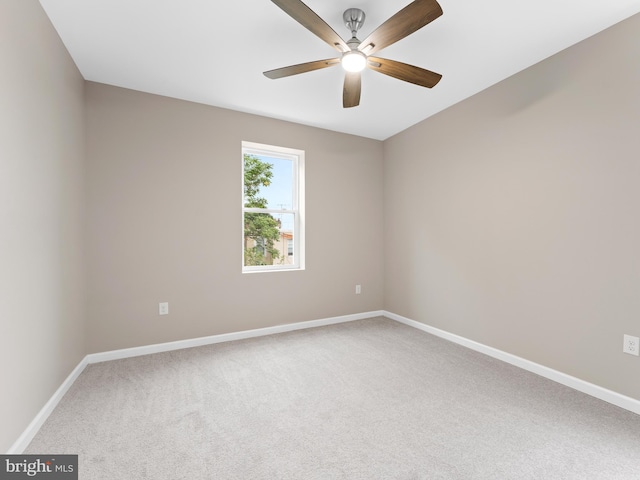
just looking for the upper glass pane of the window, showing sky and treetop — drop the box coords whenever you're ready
[244,154,293,210]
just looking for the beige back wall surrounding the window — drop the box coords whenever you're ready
[86,82,383,352]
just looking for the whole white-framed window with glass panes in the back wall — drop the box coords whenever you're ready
[242,142,304,272]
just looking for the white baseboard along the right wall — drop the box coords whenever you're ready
[382,311,640,415]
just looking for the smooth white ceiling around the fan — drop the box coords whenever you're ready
[40,0,640,140]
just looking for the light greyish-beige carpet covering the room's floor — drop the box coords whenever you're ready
[25,318,640,480]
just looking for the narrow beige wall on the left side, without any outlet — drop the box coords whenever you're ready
[0,0,85,452]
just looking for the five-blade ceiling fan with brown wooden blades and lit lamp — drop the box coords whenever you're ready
[264,0,442,108]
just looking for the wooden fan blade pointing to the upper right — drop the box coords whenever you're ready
[358,0,442,55]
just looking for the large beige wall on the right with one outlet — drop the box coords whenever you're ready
[384,16,640,399]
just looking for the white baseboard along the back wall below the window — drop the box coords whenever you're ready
[86,310,383,363]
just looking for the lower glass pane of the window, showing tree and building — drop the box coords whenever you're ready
[244,213,295,266]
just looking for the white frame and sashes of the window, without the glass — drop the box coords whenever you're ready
[240,141,305,273]
